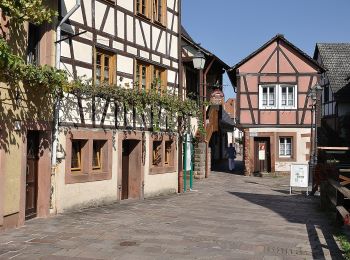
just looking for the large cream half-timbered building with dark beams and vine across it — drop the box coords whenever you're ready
[53,0,181,212]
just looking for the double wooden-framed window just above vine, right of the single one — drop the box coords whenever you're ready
[135,61,167,92]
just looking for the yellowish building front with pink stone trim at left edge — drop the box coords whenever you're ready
[0,5,55,229]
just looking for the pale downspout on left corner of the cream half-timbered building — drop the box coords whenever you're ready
[51,0,81,212]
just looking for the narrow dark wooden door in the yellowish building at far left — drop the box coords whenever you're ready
[25,131,39,219]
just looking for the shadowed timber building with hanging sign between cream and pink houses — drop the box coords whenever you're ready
[181,28,233,179]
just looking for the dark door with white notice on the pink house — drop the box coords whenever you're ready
[254,138,271,172]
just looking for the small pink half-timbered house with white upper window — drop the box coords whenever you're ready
[229,35,324,175]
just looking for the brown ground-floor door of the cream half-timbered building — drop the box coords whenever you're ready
[121,140,141,200]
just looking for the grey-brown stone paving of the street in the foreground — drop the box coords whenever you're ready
[0,167,342,260]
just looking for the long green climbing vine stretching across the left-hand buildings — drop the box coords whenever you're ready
[0,0,204,133]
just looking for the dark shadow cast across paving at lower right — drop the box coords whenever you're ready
[228,191,344,259]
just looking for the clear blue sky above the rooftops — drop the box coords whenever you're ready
[182,0,350,99]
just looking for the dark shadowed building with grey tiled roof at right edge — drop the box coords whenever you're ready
[314,43,350,146]
